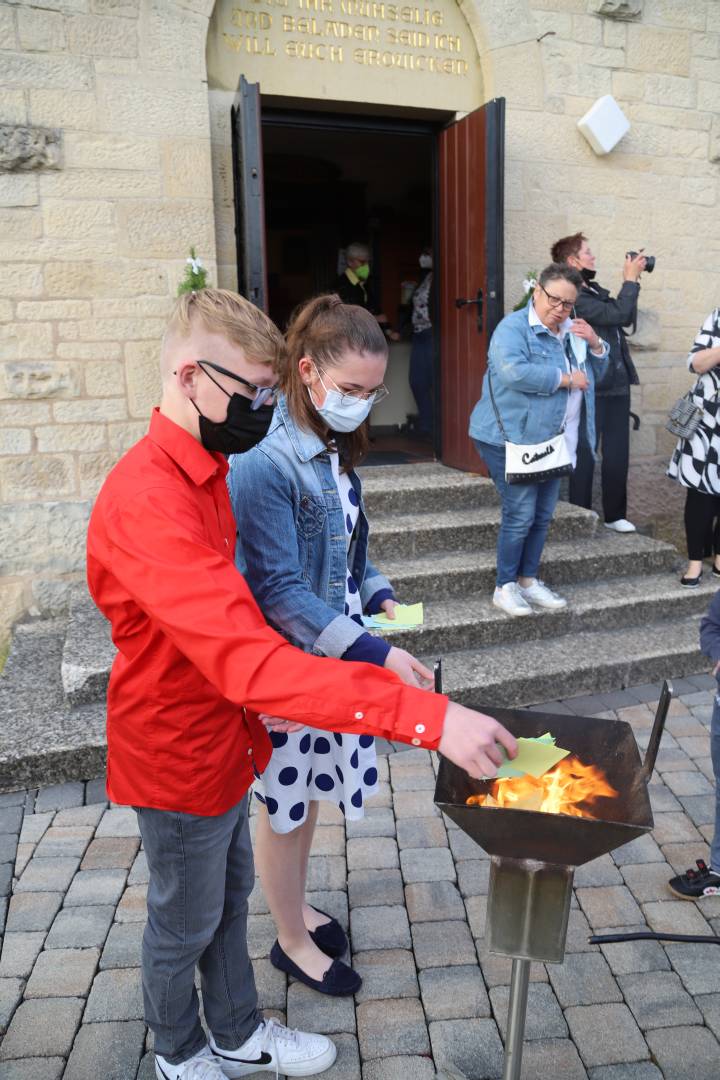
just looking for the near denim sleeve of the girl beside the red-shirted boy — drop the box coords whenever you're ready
[229,448,365,658]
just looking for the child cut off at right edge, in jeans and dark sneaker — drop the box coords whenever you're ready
[668,592,720,900]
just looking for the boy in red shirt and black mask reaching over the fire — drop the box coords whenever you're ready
[87,289,516,1080]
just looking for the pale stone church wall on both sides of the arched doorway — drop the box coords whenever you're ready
[0,0,720,636]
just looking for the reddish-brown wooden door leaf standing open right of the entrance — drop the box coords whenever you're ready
[438,97,505,472]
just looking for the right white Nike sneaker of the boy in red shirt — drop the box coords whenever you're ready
[209,1018,338,1080]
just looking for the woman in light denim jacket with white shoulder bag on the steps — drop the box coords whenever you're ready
[470,262,608,616]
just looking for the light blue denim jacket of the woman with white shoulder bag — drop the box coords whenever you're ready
[470,301,608,454]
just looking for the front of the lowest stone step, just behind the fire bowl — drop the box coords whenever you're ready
[436,615,707,710]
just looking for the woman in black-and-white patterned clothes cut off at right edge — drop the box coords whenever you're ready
[667,308,720,589]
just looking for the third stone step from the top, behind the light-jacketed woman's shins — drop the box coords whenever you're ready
[380,529,678,604]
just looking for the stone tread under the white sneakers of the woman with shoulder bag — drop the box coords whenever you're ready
[371,572,715,657]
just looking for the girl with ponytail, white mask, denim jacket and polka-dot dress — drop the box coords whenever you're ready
[229,296,432,995]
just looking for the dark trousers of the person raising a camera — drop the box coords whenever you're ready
[569,394,630,522]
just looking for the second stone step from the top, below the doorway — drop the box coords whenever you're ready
[370,502,598,565]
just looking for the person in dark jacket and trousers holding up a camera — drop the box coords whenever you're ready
[552,232,654,532]
